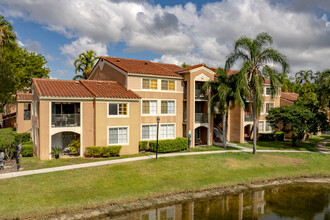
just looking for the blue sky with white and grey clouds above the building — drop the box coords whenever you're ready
[0,0,330,79]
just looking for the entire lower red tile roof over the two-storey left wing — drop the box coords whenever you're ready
[32,79,140,99]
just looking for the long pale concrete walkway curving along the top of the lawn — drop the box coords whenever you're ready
[0,147,315,179]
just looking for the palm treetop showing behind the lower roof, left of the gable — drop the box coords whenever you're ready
[73,50,100,80]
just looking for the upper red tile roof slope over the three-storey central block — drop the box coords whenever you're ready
[101,57,182,77]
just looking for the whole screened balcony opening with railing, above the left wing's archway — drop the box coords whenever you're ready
[52,103,80,127]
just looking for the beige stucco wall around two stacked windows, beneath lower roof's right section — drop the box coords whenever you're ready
[95,100,140,155]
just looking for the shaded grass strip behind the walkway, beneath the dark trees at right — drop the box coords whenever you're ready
[238,135,330,151]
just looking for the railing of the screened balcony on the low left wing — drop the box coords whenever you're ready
[52,114,80,127]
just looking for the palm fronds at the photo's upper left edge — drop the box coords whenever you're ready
[0,16,16,48]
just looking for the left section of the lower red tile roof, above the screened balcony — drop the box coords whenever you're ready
[32,79,93,98]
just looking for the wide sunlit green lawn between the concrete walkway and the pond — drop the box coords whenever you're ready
[0,153,330,218]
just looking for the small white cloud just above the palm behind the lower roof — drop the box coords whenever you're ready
[60,37,107,66]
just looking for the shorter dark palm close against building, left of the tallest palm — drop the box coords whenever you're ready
[204,68,248,148]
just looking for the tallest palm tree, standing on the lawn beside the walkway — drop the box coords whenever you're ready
[225,33,289,154]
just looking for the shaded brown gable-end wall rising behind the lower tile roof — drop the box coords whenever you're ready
[89,60,126,87]
